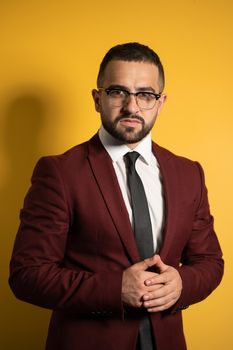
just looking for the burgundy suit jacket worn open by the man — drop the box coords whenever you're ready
[10,135,223,350]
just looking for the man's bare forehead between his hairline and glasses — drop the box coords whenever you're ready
[103,60,159,91]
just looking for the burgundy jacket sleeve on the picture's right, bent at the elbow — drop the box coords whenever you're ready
[172,163,224,312]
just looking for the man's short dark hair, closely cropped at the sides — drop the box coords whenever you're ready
[97,42,165,92]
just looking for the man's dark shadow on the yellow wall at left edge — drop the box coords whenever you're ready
[0,88,56,350]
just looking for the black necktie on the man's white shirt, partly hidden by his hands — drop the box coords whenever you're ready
[125,152,155,350]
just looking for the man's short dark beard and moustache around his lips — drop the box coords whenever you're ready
[102,115,154,144]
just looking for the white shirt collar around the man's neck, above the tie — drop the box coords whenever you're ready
[99,126,152,164]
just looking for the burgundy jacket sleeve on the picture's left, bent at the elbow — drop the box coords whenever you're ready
[9,157,123,317]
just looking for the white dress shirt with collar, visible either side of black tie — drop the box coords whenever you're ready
[99,126,164,252]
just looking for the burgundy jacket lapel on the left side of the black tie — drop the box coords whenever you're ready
[88,135,140,263]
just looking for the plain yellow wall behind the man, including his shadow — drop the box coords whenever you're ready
[0,0,233,350]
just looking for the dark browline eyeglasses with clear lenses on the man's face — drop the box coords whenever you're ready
[99,87,161,109]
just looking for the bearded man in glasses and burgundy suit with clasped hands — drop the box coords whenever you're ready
[10,43,223,350]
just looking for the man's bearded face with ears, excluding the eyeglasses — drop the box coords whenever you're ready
[92,60,166,148]
